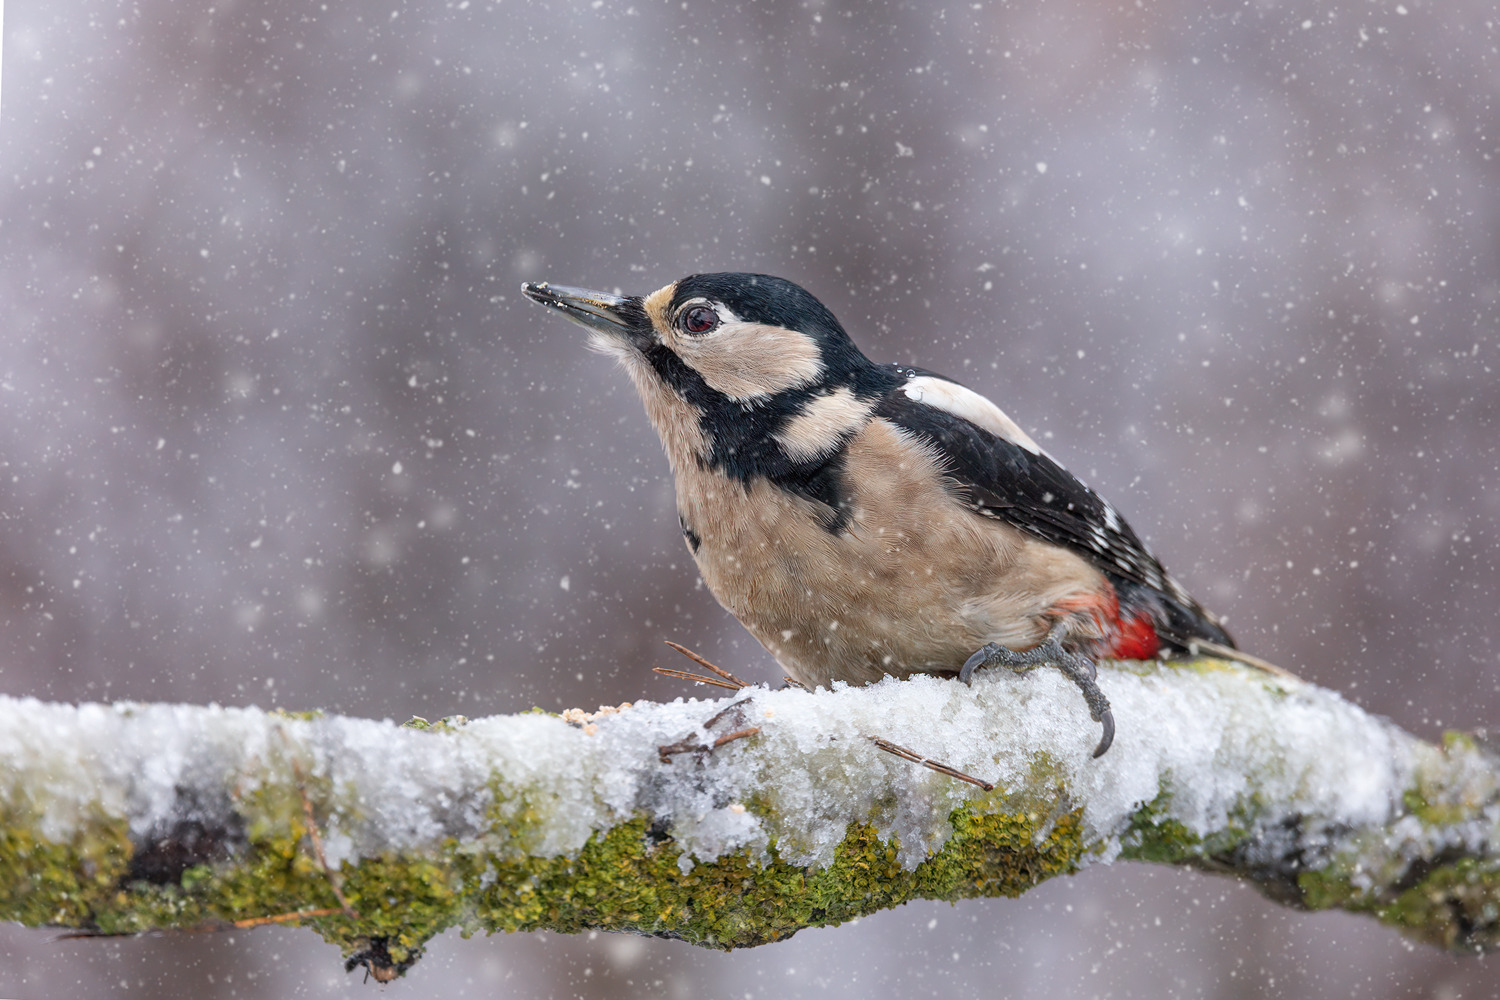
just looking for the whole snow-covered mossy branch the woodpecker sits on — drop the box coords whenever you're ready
[0,660,1500,978]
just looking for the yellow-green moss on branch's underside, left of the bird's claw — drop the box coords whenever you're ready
[0,789,1083,975]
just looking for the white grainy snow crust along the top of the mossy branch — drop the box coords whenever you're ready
[0,666,1430,868]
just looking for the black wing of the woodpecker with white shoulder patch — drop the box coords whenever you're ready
[875,366,1233,646]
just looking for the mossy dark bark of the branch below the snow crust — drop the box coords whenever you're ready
[0,668,1500,978]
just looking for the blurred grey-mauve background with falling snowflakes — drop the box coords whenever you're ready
[0,0,1500,1000]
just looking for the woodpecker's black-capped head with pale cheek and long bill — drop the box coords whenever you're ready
[522,274,881,475]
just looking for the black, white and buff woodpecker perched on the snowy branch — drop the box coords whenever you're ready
[522,273,1259,757]
